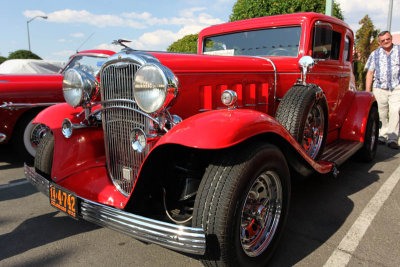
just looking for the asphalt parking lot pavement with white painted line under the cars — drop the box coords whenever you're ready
[0,145,400,267]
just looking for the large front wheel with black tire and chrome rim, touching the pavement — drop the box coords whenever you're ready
[193,143,290,266]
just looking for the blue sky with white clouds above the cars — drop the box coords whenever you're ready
[0,0,400,61]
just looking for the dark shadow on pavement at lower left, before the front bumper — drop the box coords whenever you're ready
[0,212,99,261]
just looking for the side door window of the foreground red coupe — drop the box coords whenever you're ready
[312,22,342,60]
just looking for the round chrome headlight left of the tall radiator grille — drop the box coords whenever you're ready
[63,69,98,108]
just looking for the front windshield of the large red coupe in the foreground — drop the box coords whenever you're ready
[203,26,301,57]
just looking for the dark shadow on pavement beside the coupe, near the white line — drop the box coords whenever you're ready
[270,147,399,266]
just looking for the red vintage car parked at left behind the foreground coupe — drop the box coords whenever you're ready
[0,50,115,160]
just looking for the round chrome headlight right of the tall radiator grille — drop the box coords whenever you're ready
[133,64,178,113]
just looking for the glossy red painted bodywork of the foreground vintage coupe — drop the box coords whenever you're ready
[36,13,375,207]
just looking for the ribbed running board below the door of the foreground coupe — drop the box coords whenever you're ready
[321,139,364,165]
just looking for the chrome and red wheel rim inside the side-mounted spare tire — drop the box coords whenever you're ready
[301,104,325,159]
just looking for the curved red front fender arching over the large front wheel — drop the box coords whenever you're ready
[156,109,292,149]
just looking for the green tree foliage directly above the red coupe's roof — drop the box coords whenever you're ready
[229,0,343,21]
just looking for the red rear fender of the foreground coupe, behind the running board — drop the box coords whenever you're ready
[340,92,376,142]
